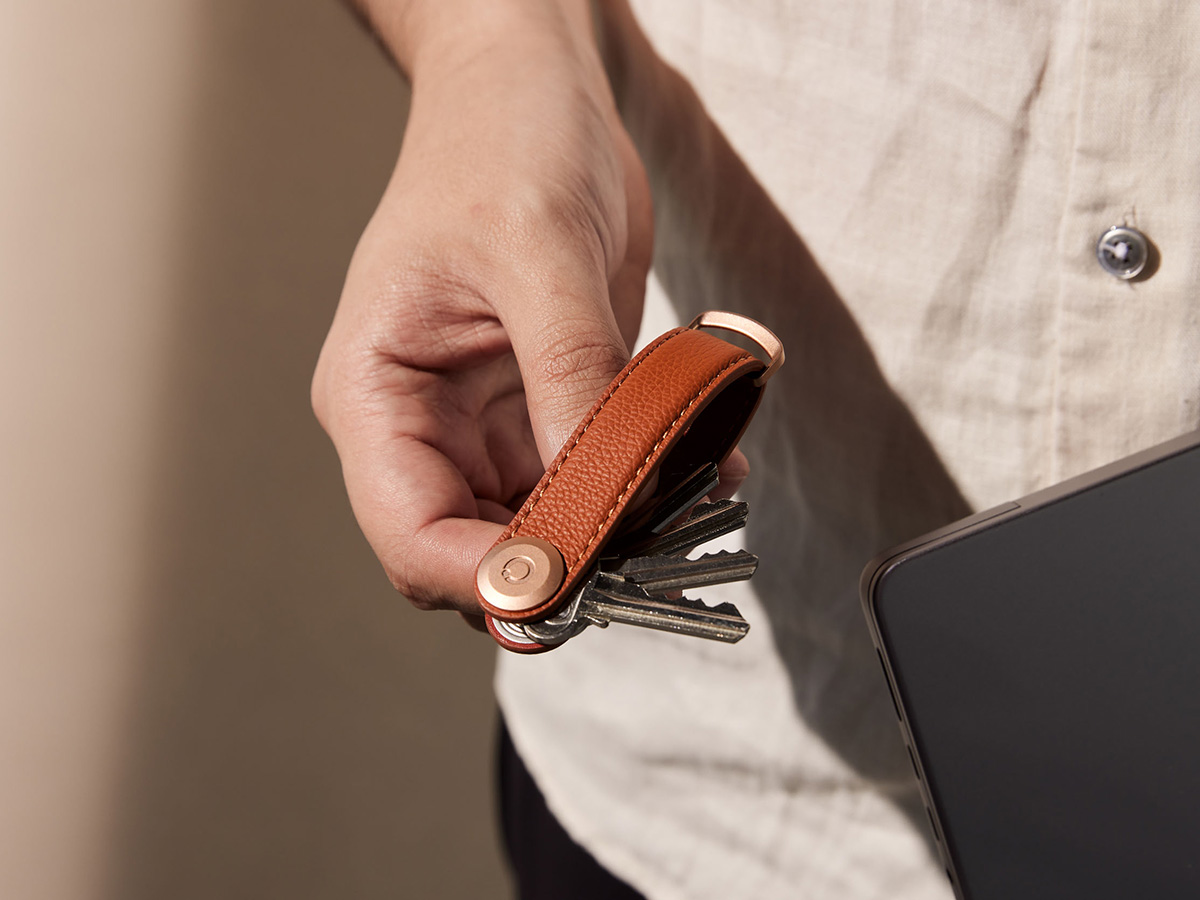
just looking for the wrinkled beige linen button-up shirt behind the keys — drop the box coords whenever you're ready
[497,0,1200,900]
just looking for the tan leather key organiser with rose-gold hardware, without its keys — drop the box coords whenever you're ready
[475,311,784,653]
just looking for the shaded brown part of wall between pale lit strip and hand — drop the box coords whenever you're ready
[108,0,506,900]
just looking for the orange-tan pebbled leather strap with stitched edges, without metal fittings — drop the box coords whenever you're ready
[475,328,767,628]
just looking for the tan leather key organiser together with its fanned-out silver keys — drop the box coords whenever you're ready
[475,312,784,653]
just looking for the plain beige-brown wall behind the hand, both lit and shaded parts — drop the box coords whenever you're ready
[0,0,509,900]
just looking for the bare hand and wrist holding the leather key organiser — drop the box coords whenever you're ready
[304,0,653,614]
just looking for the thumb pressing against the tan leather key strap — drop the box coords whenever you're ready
[500,234,629,464]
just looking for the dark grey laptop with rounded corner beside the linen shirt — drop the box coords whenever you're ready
[862,432,1200,900]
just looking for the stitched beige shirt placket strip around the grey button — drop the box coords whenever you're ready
[1049,0,1200,480]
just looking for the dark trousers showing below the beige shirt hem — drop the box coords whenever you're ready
[497,719,644,900]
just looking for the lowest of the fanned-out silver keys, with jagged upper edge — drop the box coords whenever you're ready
[580,580,750,643]
